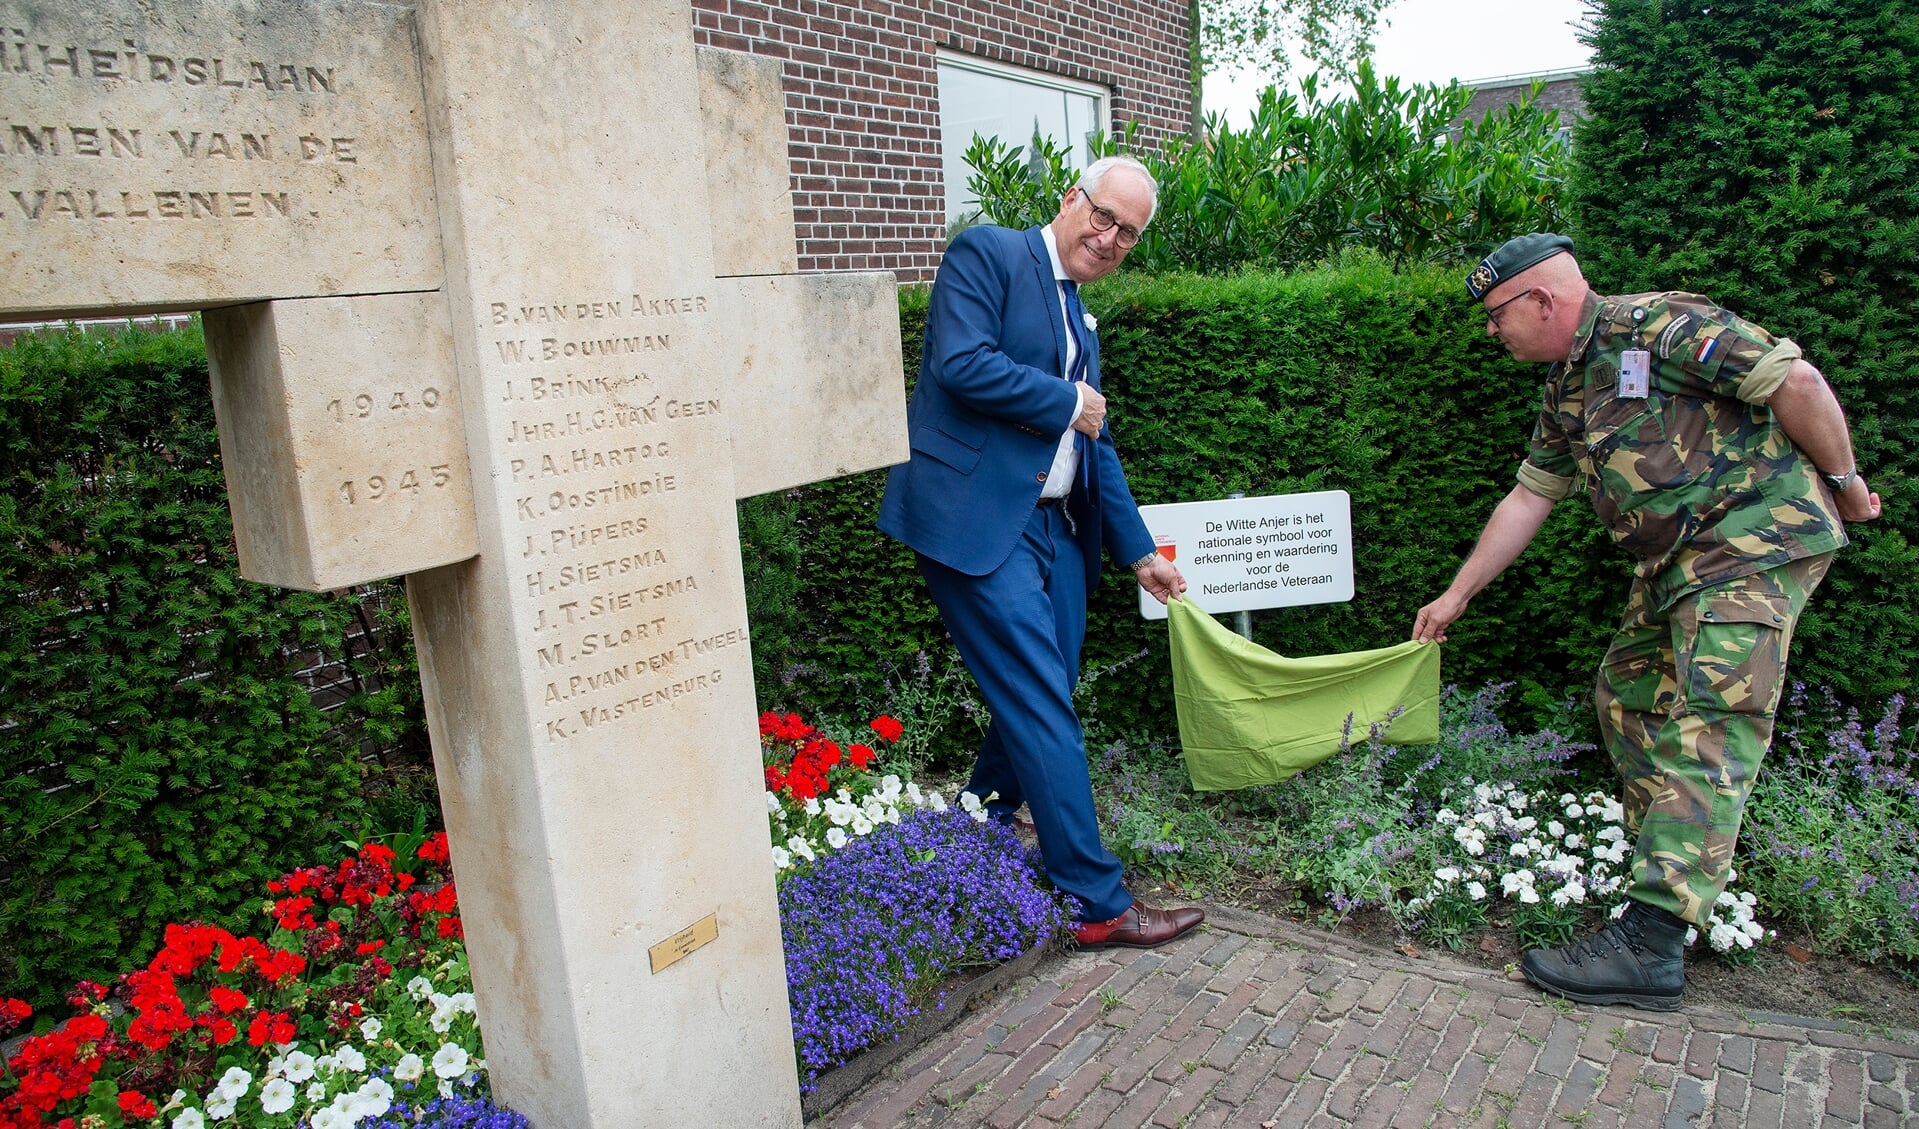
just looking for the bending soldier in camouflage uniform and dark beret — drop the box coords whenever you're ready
[1412,234,1879,1010]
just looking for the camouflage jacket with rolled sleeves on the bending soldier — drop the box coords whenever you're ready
[1520,292,1846,607]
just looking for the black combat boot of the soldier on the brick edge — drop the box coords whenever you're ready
[1520,901,1687,1012]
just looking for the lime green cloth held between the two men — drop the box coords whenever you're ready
[1167,599,1439,791]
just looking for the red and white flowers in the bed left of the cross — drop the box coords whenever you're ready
[0,833,502,1129]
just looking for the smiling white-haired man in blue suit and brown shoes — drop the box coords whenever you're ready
[879,157,1203,949]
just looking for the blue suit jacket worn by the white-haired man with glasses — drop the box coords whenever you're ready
[879,227,1153,591]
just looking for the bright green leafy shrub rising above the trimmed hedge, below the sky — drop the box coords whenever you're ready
[967,63,1568,273]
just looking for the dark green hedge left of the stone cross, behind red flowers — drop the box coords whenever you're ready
[0,324,430,1004]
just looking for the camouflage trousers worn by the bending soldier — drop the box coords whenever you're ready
[1597,553,1833,925]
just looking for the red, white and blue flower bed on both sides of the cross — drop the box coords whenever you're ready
[0,714,1069,1129]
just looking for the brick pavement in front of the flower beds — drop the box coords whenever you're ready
[812,908,1919,1129]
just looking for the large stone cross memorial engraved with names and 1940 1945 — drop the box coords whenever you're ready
[0,0,906,1129]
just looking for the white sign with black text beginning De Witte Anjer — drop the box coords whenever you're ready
[1140,490,1353,620]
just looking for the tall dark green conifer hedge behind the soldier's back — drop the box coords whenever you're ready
[1570,0,1919,701]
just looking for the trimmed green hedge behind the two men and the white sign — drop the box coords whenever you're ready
[762,257,1919,739]
